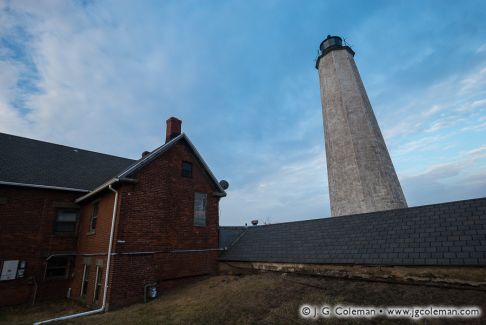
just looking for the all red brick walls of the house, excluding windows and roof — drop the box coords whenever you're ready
[0,137,220,306]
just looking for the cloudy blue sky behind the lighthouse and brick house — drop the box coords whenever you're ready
[0,0,486,225]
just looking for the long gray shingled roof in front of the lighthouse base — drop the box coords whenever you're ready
[220,198,486,266]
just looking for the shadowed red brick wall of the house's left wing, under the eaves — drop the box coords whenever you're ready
[0,185,81,306]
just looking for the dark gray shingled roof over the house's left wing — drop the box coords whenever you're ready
[0,133,136,190]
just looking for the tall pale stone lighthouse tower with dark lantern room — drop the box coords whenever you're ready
[316,35,407,217]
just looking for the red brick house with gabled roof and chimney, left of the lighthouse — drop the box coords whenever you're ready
[0,118,226,307]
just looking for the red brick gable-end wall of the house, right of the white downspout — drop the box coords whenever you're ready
[91,142,219,307]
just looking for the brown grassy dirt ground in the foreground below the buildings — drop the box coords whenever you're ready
[0,273,486,325]
